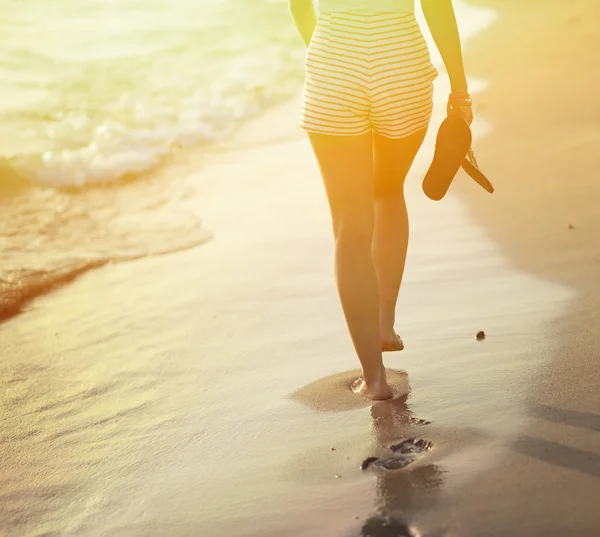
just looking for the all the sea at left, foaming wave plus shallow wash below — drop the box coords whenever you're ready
[0,0,304,318]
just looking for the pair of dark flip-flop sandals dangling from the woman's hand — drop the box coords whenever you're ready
[423,113,494,201]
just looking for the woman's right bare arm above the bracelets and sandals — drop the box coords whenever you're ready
[421,0,469,94]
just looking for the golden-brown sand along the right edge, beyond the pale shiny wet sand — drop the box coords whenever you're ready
[428,1,600,537]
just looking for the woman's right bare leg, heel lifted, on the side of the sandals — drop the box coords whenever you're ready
[373,129,427,350]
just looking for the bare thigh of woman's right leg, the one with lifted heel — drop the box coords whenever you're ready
[373,127,427,199]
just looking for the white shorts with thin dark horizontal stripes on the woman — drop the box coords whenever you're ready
[300,13,437,138]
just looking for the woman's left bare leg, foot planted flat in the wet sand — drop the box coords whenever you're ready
[309,133,392,399]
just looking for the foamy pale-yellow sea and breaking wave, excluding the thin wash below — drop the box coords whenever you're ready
[0,0,302,186]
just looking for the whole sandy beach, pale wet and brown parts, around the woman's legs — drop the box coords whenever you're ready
[0,0,600,537]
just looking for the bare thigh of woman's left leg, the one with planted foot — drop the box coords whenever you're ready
[309,132,374,236]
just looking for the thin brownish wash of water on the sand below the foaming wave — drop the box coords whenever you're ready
[0,170,211,320]
